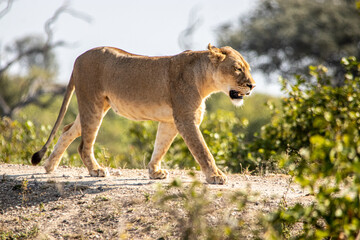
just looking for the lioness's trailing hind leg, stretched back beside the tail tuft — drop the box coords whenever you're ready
[44,115,81,173]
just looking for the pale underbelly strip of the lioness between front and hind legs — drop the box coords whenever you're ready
[109,99,174,122]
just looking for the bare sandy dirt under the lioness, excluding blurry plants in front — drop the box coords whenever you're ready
[0,164,311,239]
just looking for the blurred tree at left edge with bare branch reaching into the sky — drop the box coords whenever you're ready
[0,0,91,118]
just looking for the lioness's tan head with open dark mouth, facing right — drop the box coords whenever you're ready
[208,44,255,106]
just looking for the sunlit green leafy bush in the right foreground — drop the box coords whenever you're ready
[262,57,360,239]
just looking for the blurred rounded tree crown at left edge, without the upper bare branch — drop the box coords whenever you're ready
[0,36,58,117]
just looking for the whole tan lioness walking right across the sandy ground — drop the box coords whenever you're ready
[31,44,255,184]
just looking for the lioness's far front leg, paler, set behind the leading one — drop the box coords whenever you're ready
[148,122,177,179]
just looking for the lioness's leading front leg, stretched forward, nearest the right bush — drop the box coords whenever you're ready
[176,120,227,184]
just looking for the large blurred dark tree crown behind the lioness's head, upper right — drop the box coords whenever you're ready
[218,0,360,83]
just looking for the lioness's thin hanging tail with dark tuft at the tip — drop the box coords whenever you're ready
[31,75,75,165]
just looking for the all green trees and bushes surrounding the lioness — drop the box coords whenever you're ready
[0,0,360,239]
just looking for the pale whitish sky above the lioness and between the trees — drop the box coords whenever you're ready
[0,0,279,94]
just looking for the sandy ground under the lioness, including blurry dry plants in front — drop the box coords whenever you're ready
[0,164,311,239]
